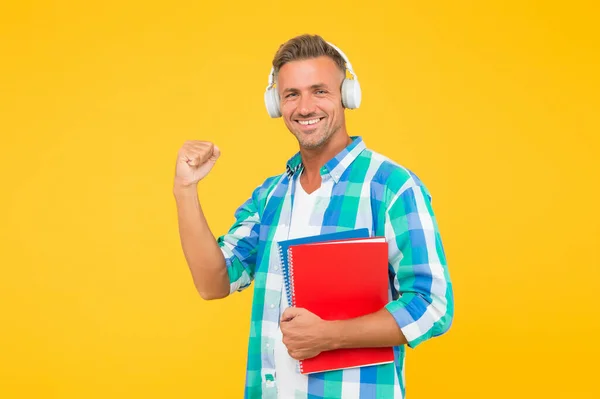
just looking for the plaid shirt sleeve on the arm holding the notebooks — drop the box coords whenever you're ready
[385,182,454,348]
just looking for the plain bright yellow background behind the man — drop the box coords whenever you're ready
[0,0,600,399]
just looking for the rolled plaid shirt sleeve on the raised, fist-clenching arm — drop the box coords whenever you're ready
[217,188,260,294]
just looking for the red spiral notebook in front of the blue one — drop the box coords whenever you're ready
[286,237,394,374]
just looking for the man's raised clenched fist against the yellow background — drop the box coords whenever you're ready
[175,140,221,187]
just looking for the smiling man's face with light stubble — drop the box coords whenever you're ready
[277,56,345,149]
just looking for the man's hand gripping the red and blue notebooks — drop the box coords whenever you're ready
[281,307,336,360]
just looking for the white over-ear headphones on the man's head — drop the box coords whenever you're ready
[265,42,362,118]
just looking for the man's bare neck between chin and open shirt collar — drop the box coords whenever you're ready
[300,133,352,188]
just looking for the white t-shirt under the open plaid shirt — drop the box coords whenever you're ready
[274,177,320,399]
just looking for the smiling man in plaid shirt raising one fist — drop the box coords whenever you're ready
[174,35,453,398]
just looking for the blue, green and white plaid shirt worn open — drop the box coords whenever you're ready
[217,137,454,399]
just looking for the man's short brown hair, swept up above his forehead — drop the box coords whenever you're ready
[273,34,346,76]
